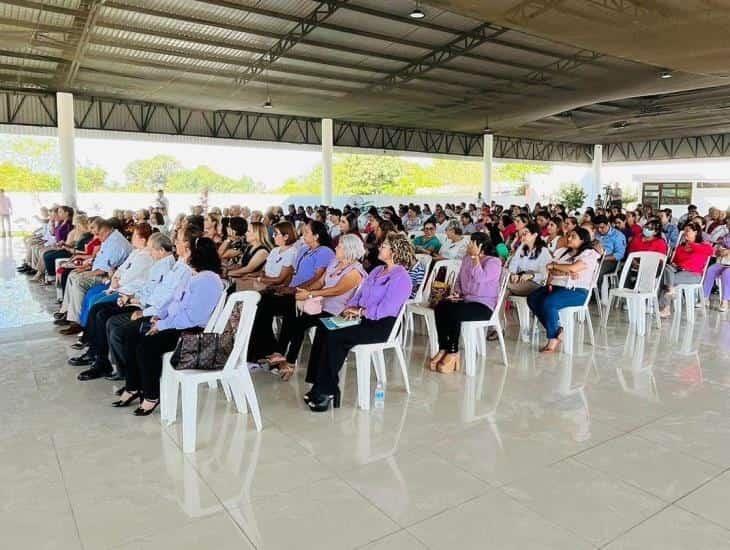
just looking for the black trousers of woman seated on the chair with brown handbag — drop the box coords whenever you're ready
[125,329,182,401]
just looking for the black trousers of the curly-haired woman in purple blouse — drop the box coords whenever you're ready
[306,317,395,395]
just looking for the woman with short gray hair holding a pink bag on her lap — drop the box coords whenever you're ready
[265,234,367,381]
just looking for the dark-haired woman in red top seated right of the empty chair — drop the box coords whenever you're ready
[659,222,713,317]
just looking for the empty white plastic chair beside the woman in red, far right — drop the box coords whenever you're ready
[603,252,667,334]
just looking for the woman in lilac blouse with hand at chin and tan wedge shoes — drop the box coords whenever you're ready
[429,233,502,373]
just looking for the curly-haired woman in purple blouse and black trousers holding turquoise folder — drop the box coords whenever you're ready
[304,233,413,412]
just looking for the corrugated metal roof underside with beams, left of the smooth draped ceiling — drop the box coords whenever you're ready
[0,0,725,144]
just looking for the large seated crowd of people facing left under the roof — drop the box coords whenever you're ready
[18,201,730,416]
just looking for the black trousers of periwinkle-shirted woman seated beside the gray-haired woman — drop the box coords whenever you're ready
[248,294,297,361]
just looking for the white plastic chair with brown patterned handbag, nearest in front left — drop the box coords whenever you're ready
[160,290,261,453]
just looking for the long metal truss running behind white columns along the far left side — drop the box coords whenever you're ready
[0,90,591,163]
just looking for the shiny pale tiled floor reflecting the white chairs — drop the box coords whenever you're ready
[0,241,730,550]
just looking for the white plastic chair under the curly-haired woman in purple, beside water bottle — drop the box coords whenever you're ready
[350,306,411,410]
